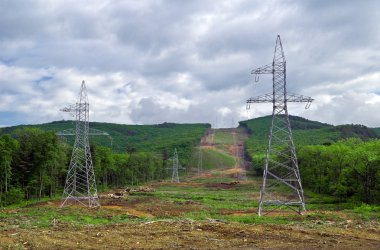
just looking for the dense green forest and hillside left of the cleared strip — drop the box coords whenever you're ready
[0,122,210,205]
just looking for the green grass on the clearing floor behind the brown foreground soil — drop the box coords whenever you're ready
[0,177,380,230]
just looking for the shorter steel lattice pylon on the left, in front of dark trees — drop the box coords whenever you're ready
[61,81,100,207]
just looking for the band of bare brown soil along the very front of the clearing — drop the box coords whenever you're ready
[0,220,380,249]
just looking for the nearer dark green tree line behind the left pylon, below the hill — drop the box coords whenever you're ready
[0,128,186,205]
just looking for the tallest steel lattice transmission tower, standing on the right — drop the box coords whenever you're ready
[247,35,314,216]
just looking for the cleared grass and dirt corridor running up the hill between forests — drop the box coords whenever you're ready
[0,129,380,249]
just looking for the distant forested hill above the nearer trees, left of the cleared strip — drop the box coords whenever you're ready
[0,121,210,154]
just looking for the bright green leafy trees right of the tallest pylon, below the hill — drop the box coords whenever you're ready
[298,138,380,204]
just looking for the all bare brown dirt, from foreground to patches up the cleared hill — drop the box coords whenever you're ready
[0,132,380,249]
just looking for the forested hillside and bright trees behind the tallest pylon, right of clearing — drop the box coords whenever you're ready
[240,116,380,204]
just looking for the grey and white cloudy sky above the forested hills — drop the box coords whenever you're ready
[0,0,380,127]
